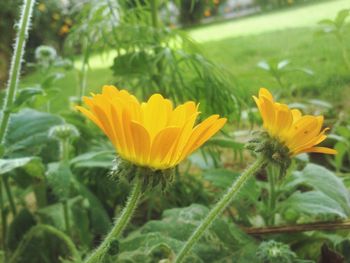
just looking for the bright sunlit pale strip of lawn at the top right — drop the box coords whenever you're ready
[189,0,350,42]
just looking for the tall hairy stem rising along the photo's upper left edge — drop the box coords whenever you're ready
[0,0,35,145]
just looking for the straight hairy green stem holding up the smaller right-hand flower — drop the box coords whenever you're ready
[175,156,266,263]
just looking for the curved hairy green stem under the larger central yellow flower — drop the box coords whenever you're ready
[85,176,142,263]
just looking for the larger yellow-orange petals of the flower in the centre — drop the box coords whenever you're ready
[76,86,226,170]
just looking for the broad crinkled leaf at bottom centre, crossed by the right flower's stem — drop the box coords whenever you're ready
[117,204,256,262]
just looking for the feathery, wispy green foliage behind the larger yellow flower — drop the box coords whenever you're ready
[68,0,240,119]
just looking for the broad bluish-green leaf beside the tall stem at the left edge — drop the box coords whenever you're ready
[5,109,63,156]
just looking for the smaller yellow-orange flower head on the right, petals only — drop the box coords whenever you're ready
[253,88,337,156]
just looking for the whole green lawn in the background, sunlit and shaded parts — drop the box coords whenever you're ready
[22,0,350,111]
